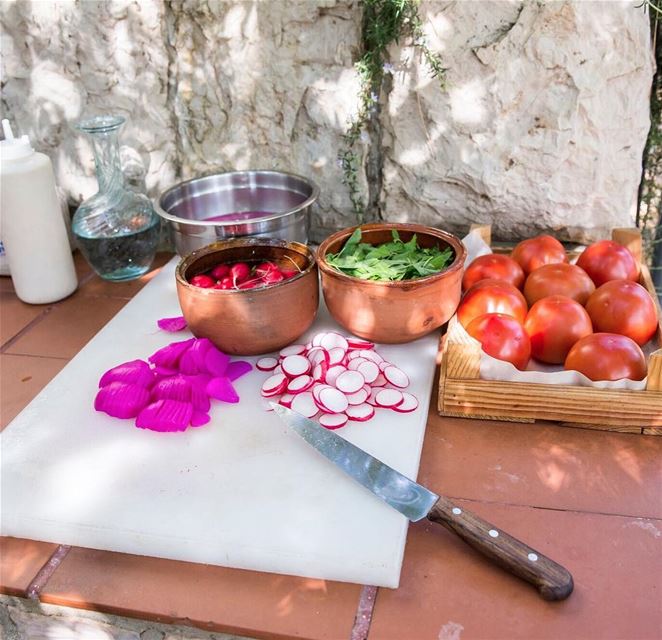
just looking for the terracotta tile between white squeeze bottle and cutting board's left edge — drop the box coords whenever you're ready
[6,291,127,358]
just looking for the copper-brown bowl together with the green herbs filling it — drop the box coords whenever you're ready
[317,223,467,344]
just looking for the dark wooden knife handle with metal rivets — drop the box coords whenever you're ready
[428,497,574,600]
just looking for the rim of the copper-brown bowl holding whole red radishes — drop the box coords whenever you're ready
[175,237,317,295]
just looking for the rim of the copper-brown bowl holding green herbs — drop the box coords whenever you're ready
[317,222,467,289]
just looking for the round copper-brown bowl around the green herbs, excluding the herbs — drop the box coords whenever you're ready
[317,223,467,344]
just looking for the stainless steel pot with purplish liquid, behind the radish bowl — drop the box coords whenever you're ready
[156,171,319,256]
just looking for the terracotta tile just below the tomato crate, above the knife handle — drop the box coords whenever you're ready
[419,410,662,518]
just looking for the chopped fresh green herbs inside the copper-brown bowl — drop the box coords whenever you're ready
[326,227,453,281]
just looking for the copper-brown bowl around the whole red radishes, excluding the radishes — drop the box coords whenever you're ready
[175,238,319,355]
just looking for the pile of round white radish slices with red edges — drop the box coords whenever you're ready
[256,331,418,429]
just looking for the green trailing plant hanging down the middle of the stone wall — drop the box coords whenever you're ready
[338,0,445,224]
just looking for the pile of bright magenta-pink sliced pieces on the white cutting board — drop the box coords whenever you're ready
[94,338,253,431]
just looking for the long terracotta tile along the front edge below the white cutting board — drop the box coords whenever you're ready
[41,548,361,640]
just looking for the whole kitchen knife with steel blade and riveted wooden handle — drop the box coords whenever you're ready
[271,402,573,600]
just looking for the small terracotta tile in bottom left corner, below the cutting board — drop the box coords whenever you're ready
[0,538,57,596]
